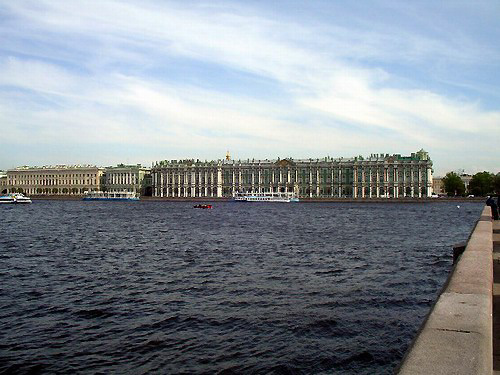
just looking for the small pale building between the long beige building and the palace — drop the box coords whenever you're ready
[104,164,149,195]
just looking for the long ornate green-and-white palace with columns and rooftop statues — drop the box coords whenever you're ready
[151,150,432,198]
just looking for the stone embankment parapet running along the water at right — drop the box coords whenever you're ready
[397,207,493,375]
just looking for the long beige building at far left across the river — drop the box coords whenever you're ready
[6,165,104,195]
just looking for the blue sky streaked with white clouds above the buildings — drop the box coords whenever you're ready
[0,0,500,176]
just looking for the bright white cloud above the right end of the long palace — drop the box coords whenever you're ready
[299,67,500,147]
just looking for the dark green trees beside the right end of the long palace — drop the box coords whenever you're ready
[443,171,500,196]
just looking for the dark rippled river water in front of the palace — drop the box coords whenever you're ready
[0,201,483,374]
